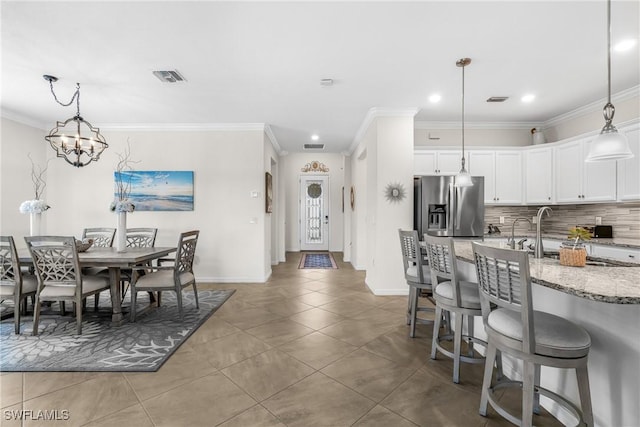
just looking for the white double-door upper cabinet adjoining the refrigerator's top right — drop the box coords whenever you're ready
[469,150,523,205]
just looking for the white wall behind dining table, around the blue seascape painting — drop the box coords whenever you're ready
[1,119,277,282]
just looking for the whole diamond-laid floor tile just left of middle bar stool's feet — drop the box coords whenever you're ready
[322,350,416,402]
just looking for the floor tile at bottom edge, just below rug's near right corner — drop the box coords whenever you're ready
[142,372,256,427]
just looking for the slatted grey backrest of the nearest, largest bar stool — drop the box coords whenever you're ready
[472,242,536,354]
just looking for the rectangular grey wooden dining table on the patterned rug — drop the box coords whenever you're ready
[18,246,177,326]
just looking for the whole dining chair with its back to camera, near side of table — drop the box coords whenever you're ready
[24,236,109,335]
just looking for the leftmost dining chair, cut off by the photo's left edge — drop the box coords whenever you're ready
[0,236,38,334]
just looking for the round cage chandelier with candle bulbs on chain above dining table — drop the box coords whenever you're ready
[43,75,109,168]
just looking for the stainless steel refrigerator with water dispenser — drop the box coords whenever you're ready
[414,175,484,237]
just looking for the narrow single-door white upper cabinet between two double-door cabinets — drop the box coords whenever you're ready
[524,147,553,204]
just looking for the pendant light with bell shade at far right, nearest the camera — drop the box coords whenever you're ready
[585,0,633,162]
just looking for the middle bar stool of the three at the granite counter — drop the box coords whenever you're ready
[424,234,487,384]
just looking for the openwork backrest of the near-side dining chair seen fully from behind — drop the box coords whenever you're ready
[24,236,82,295]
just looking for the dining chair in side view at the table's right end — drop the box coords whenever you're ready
[130,230,200,322]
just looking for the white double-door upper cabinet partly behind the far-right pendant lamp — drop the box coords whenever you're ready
[555,137,616,203]
